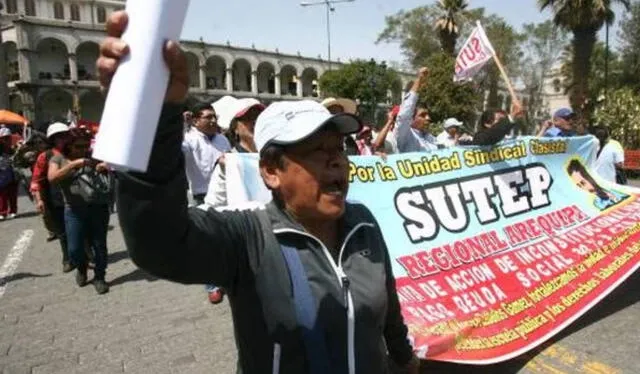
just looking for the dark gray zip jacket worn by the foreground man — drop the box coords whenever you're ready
[118,106,412,374]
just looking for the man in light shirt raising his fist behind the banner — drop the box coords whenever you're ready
[394,68,438,153]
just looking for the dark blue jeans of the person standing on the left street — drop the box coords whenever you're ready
[64,204,109,280]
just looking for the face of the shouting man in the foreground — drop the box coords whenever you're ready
[263,130,349,222]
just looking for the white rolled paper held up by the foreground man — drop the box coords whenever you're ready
[93,0,189,171]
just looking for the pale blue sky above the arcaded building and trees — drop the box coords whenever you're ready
[182,0,621,66]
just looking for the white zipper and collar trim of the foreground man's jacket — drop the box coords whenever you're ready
[274,223,375,374]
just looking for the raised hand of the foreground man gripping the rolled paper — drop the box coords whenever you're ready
[96,11,189,104]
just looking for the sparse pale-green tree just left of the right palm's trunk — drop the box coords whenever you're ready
[520,20,569,118]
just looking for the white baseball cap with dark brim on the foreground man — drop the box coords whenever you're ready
[254,100,362,152]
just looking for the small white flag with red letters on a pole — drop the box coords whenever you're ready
[453,21,495,82]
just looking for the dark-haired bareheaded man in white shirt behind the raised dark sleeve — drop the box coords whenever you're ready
[182,103,231,205]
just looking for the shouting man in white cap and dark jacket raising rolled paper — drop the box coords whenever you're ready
[97,12,426,374]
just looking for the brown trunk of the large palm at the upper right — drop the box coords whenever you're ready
[570,29,597,115]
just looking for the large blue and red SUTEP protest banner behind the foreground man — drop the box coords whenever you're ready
[227,137,640,364]
